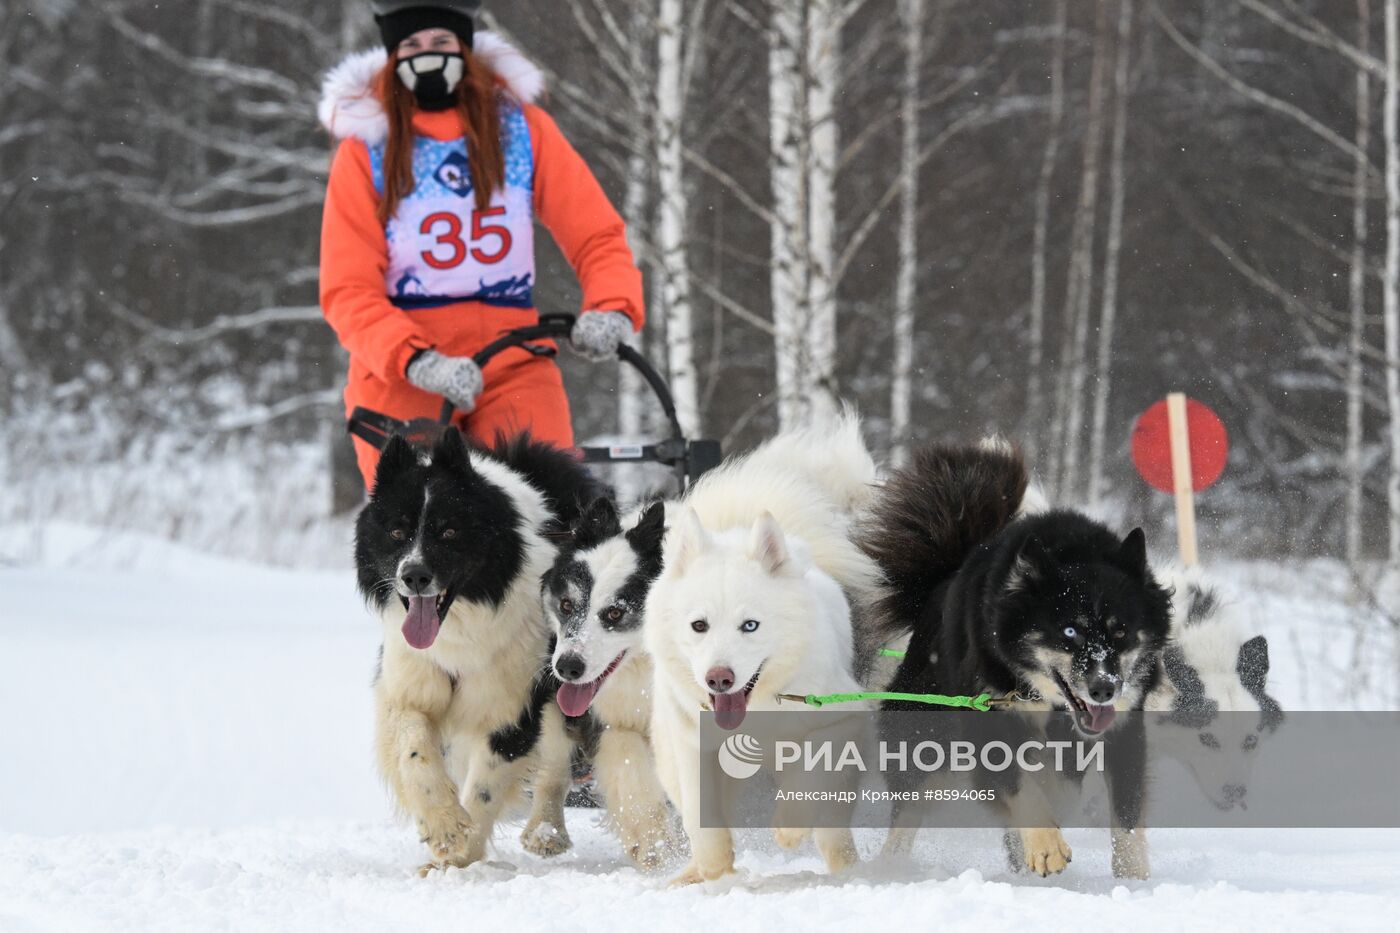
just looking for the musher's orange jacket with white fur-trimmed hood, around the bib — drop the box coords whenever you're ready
[321,36,644,383]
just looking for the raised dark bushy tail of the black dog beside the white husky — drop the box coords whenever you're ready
[860,443,1029,644]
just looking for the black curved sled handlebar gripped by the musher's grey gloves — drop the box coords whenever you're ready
[346,314,722,489]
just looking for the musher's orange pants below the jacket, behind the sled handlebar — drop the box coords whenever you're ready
[346,341,574,489]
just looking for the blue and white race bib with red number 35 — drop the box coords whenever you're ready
[370,104,535,310]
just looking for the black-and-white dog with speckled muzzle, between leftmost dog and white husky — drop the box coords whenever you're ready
[540,499,679,869]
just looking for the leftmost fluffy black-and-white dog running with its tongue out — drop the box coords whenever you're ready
[356,429,602,867]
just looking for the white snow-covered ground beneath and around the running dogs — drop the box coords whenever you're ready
[0,525,1400,933]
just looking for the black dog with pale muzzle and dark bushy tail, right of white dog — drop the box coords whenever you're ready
[861,444,1170,876]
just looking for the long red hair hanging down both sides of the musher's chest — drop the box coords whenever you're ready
[378,53,505,224]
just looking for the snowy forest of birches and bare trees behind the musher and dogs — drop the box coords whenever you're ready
[0,0,1400,565]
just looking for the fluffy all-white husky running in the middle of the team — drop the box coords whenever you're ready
[644,413,881,884]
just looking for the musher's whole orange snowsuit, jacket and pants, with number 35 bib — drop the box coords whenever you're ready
[321,42,644,488]
